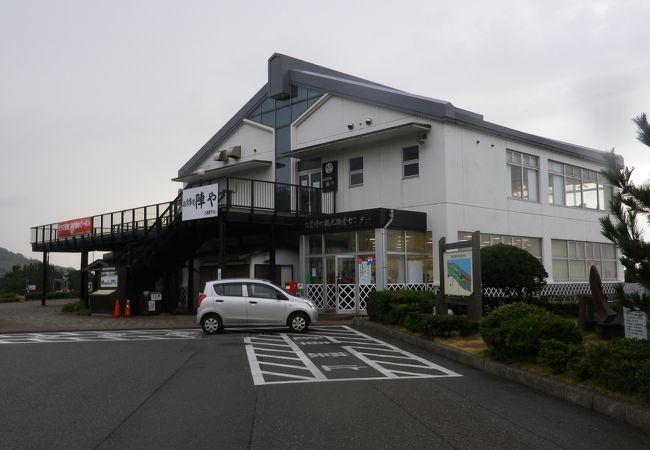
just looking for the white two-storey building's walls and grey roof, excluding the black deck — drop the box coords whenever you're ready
[175,54,623,311]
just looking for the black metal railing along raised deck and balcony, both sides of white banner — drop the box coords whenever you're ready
[30,178,335,245]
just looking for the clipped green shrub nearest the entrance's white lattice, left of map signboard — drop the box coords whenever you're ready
[366,290,434,325]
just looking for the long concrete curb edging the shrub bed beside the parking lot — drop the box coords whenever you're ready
[353,318,650,431]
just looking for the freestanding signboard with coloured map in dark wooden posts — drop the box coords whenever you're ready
[436,231,483,321]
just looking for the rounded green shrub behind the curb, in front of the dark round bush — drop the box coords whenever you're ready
[480,303,582,361]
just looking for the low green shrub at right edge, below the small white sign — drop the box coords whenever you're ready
[569,339,650,401]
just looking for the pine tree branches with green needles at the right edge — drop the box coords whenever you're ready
[600,113,650,290]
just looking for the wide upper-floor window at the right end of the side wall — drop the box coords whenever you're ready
[548,161,612,211]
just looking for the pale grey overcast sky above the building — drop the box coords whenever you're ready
[0,0,650,267]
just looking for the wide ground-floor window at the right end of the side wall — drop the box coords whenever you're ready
[551,239,616,281]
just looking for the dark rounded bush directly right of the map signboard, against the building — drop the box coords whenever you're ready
[481,244,548,300]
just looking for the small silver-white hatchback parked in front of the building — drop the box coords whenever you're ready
[196,278,318,334]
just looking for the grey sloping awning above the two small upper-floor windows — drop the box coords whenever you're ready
[283,122,431,159]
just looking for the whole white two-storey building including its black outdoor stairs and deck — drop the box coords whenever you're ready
[31,54,623,312]
